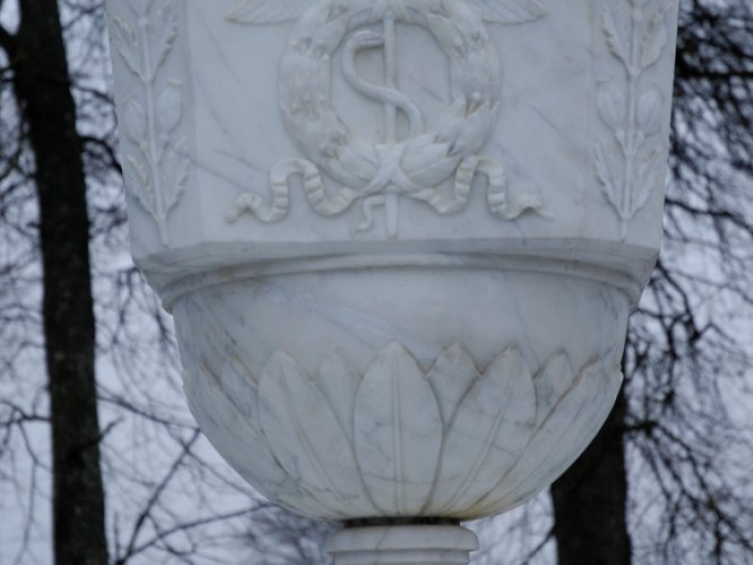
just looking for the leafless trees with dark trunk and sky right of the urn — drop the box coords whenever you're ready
[552,0,753,565]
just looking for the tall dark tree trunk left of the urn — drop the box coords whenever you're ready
[0,0,107,565]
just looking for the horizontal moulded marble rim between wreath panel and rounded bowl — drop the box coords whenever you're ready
[154,247,648,311]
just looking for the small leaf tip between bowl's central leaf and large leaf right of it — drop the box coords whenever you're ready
[428,343,479,427]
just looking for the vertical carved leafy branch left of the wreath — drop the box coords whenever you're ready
[112,0,190,245]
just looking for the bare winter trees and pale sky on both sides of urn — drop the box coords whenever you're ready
[0,0,753,565]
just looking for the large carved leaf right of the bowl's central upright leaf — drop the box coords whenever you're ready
[430,348,536,513]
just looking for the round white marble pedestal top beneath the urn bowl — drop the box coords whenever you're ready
[327,525,478,565]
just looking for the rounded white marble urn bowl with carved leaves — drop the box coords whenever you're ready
[173,264,630,521]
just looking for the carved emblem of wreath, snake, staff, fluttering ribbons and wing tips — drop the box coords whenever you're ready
[225,0,547,238]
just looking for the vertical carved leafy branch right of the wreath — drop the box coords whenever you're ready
[594,0,669,239]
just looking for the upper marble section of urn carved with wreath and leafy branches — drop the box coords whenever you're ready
[107,0,676,256]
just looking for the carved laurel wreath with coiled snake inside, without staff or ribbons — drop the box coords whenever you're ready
[280,0,501,215]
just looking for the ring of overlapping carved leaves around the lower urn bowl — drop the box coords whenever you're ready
[184,343,621,519]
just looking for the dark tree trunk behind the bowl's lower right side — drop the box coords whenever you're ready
[551,378,631,565]
